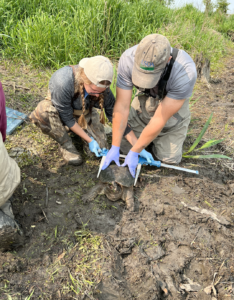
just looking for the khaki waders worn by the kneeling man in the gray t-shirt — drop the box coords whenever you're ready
[121,95,190,164]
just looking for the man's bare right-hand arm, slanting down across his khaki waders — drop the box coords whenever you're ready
[131,97,185,153]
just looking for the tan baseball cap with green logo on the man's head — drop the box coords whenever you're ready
[132,34,171,89]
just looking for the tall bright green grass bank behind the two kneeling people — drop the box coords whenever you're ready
[0,0,234,68]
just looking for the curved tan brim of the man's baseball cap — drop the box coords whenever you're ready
[132,65,161,89]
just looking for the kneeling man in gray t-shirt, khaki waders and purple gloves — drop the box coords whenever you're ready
[103,34,197,177]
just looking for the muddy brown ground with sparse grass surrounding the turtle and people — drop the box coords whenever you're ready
[0,52,234,300]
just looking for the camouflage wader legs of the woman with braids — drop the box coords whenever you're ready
[29,100,107,153]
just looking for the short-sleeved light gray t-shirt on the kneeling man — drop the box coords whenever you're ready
[117,45,197,100]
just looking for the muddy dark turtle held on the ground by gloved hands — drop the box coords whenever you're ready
[82,165,134,211]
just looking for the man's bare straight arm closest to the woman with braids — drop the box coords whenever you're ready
[112,87,132,147]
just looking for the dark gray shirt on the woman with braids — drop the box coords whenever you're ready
[49,66,115,128]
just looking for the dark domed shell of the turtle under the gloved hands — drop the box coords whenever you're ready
[100,165,134,187]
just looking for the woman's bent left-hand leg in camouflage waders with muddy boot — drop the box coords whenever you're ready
[29,100,82,166]
